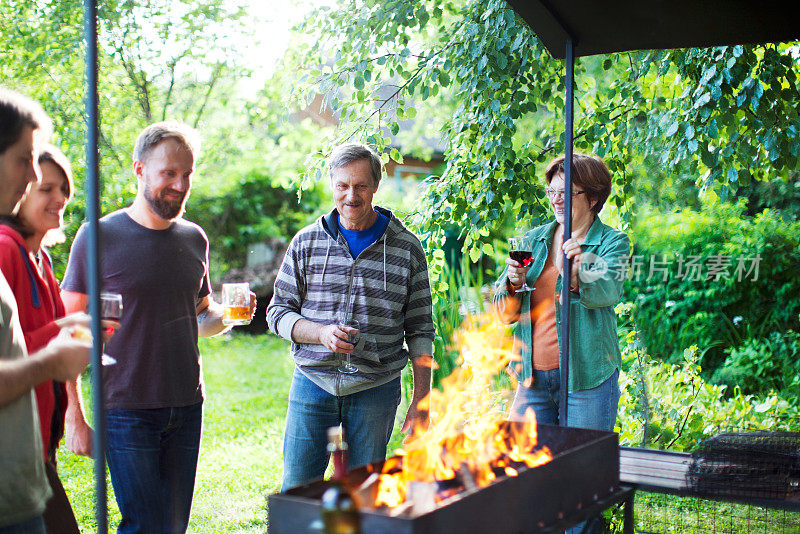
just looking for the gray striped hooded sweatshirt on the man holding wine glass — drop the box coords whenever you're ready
[267,207,434,396]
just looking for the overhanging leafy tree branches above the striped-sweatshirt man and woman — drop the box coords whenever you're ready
[293,0,800,284]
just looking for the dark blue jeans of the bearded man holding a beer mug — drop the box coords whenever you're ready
[106,403,203,534]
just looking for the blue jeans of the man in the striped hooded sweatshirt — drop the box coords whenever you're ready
[281,368,400,491]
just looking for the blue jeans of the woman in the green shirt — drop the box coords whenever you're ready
[511,369,619,432]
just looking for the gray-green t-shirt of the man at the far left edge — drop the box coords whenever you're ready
[0,273,50,527]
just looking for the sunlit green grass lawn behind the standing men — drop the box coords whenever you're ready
[58,334,408,534]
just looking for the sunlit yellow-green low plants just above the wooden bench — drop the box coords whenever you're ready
[615,332,800,451]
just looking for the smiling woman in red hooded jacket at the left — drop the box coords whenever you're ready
[0,145,89,534]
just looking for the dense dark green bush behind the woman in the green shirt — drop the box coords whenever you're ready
[625,203,800,377]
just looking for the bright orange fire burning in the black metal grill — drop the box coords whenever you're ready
[375,314,552,508]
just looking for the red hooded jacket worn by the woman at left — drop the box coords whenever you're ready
[0,224,67,458]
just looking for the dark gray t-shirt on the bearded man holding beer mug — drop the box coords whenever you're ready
[61,211,211,409]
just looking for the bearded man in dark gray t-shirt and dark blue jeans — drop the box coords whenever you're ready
[61,122,255,533]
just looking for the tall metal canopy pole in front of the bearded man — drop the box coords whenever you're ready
[83,0,108,534]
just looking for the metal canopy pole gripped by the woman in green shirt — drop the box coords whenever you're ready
[558,38,575,426]
